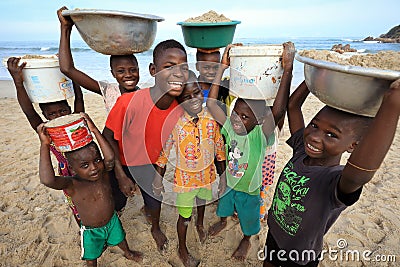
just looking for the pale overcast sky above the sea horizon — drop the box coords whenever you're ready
[0,0,400,41]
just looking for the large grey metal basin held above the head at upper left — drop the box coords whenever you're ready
[62,9,164,55]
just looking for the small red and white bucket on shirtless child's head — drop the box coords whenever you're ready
[46,114,93,152]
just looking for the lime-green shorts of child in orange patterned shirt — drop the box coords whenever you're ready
[176,188,212,219]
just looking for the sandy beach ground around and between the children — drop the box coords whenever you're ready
[0,81,400,267]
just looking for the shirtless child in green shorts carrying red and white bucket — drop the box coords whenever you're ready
[37,113,142,266]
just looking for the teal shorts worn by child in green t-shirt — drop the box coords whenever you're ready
[217,188,261,236]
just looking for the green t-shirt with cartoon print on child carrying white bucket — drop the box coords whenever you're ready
[221,118,275,195]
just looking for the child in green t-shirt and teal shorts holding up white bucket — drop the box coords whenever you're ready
[207,42,295,260]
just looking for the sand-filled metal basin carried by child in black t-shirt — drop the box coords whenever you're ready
[295,54,400,117]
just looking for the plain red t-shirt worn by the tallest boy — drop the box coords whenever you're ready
[106,88,183,166]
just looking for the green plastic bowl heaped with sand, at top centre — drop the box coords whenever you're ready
[177,20,240,48]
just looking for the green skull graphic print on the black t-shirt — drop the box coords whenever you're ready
[272,162,310,236]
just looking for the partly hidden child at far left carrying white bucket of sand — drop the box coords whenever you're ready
[7,57,85,225]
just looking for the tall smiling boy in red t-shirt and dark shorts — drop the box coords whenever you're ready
[103,40,188,251]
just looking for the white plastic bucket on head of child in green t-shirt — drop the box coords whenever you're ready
[229,45,283,103]
